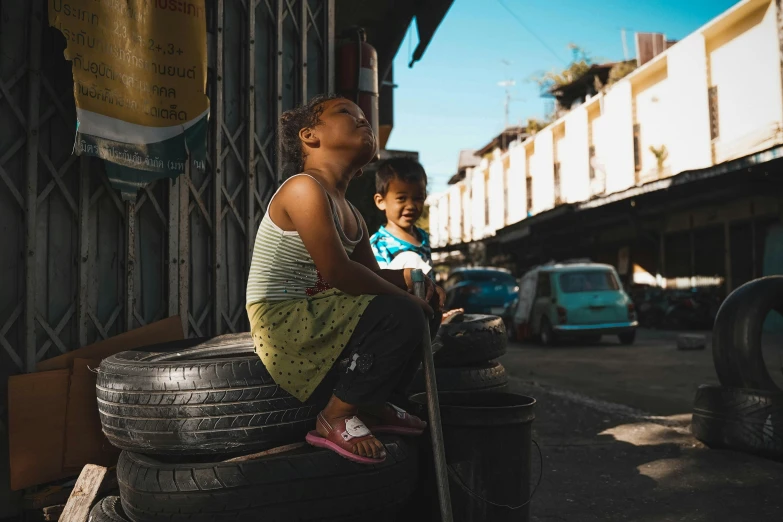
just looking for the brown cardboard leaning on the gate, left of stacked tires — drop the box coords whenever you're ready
[8,317,184,491]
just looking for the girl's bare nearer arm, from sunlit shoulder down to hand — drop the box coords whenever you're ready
[275,176,433,315]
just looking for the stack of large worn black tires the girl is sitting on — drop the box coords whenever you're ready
[91,333,417,522]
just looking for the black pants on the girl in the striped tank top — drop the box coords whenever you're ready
[326,295,441,405]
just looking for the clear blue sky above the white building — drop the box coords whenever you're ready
[387,0,737,193]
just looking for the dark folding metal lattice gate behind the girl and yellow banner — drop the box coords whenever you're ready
[0,0,335,356]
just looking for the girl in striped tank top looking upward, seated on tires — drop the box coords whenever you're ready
[247,96,444,464]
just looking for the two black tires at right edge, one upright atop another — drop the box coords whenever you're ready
[691,276,783,460]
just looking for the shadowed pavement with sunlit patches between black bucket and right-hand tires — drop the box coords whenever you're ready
[511,378,783,522]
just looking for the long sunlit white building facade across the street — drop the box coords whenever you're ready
[430,0,783,252]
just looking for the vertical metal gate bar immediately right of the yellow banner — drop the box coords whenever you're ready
[212,0,224,335]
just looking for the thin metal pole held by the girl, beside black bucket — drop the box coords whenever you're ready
[411,269,453,522]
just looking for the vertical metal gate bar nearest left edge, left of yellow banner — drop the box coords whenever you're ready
[24,2,43,372]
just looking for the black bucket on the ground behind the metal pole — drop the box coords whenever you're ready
[410,392,536,522]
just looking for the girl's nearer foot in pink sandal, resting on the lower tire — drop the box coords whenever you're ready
[305,411,386,464]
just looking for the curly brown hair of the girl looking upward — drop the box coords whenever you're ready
[277,94,342,179]
